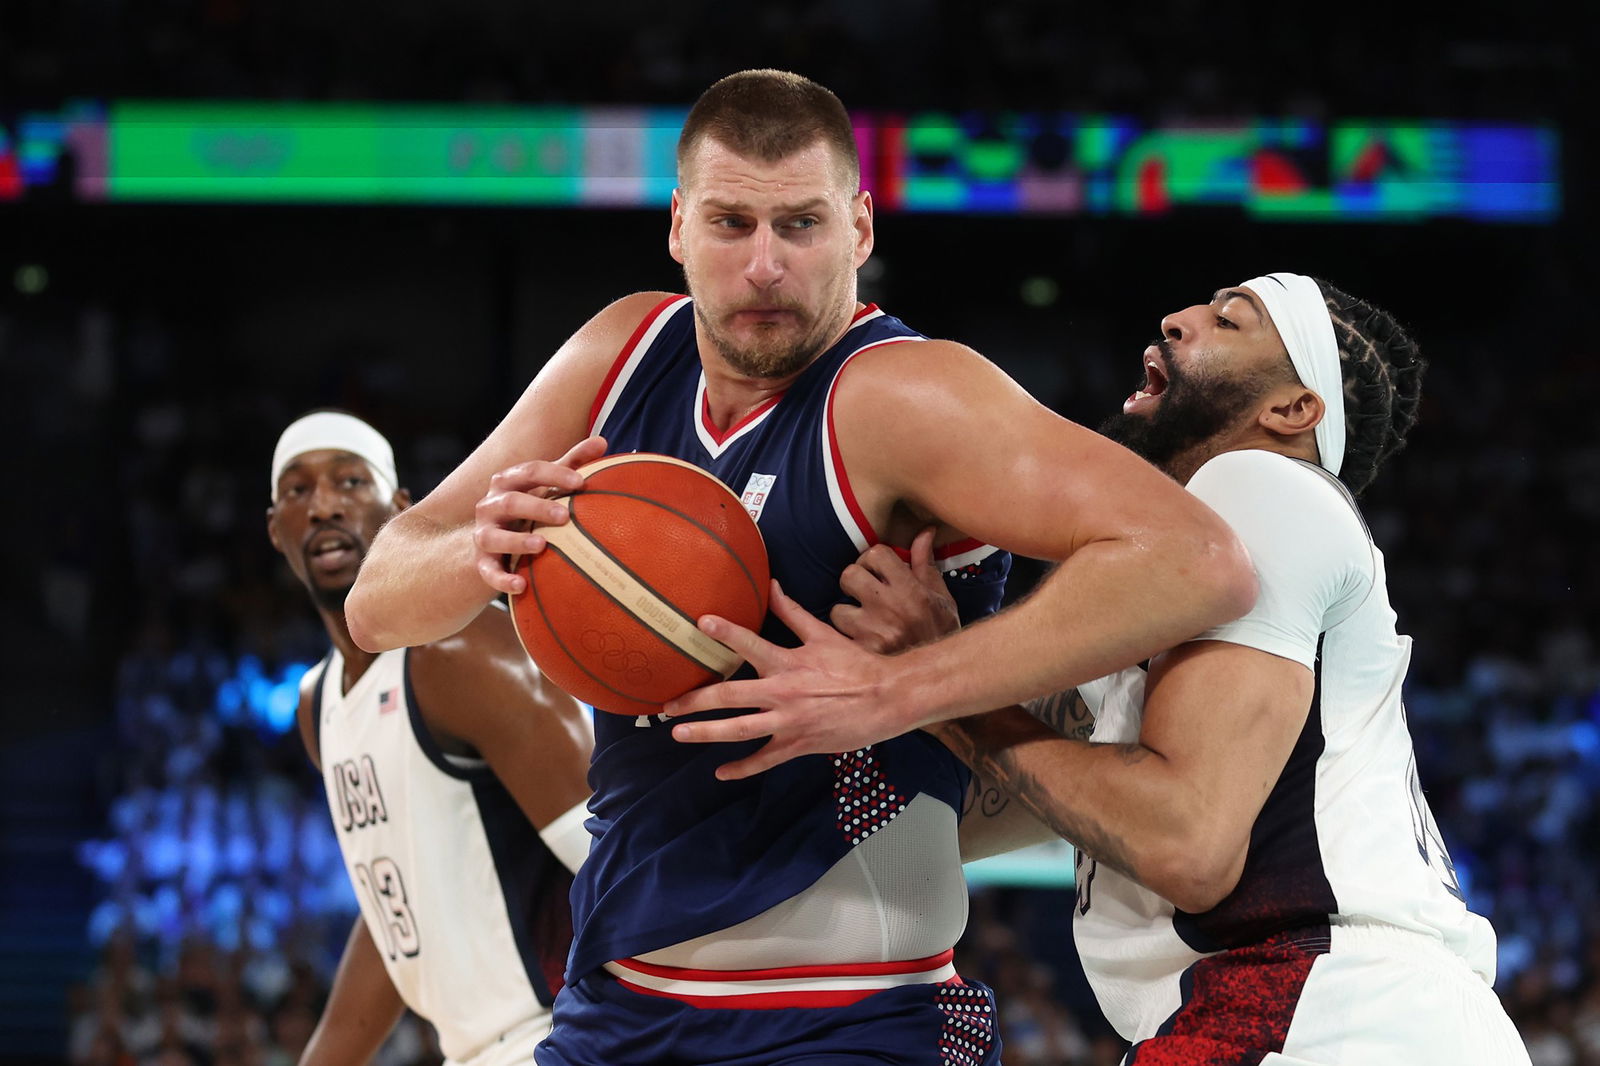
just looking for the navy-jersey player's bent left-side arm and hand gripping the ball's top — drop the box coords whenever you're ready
[346,293,667,651]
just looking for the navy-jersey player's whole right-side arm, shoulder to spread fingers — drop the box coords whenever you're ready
[667,341,1256,776]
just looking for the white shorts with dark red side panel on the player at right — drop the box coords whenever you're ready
[1123,924,1528,1066]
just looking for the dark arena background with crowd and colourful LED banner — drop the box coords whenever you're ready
[0,0,1600,1066]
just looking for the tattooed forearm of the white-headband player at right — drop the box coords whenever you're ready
[936,707,1205,901]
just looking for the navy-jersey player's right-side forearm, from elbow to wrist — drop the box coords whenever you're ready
[880,538,1254,728]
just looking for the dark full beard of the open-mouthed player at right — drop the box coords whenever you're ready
[1099,341,1270,474]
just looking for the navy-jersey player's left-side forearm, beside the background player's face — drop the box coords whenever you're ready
[344,509,494,651]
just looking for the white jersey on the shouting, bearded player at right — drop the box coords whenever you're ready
[1074,451,1494,1040]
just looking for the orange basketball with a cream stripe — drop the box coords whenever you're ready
[510,453,768,715]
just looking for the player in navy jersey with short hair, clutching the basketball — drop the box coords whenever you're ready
[350,70,1254,1066]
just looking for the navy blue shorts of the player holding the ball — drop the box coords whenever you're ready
[533,972,1000,1066]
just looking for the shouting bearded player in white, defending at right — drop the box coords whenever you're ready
[793,274,1528,1066]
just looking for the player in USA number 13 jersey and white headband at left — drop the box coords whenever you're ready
[267,411,590,1066]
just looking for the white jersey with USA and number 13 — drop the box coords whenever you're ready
[315,648,571,1066]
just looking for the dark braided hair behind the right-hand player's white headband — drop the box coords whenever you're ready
[1312,279,1427,496]
